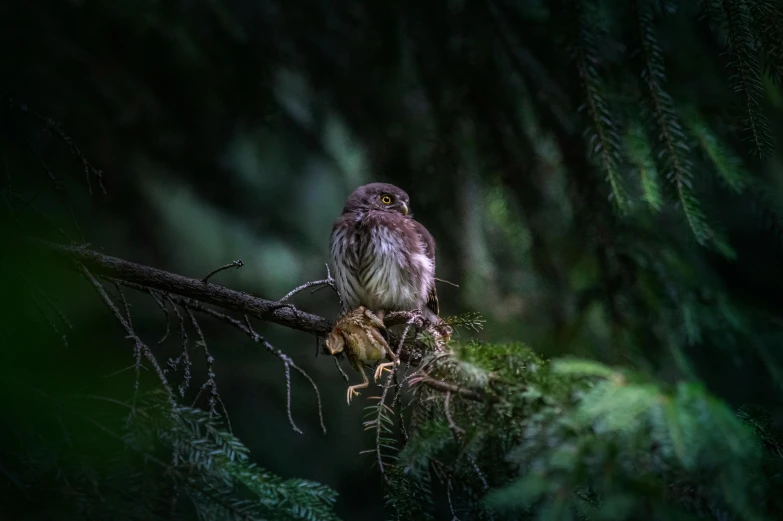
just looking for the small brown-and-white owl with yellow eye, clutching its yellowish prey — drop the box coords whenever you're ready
[327,183,448,403]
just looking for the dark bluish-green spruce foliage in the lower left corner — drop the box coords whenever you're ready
[0,380,337,521]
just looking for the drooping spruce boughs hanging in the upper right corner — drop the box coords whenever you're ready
[550,0,783,252]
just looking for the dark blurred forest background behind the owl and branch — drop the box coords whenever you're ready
[0,0,783,520]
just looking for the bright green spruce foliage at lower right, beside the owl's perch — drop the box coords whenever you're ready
[388,343,783,520]
